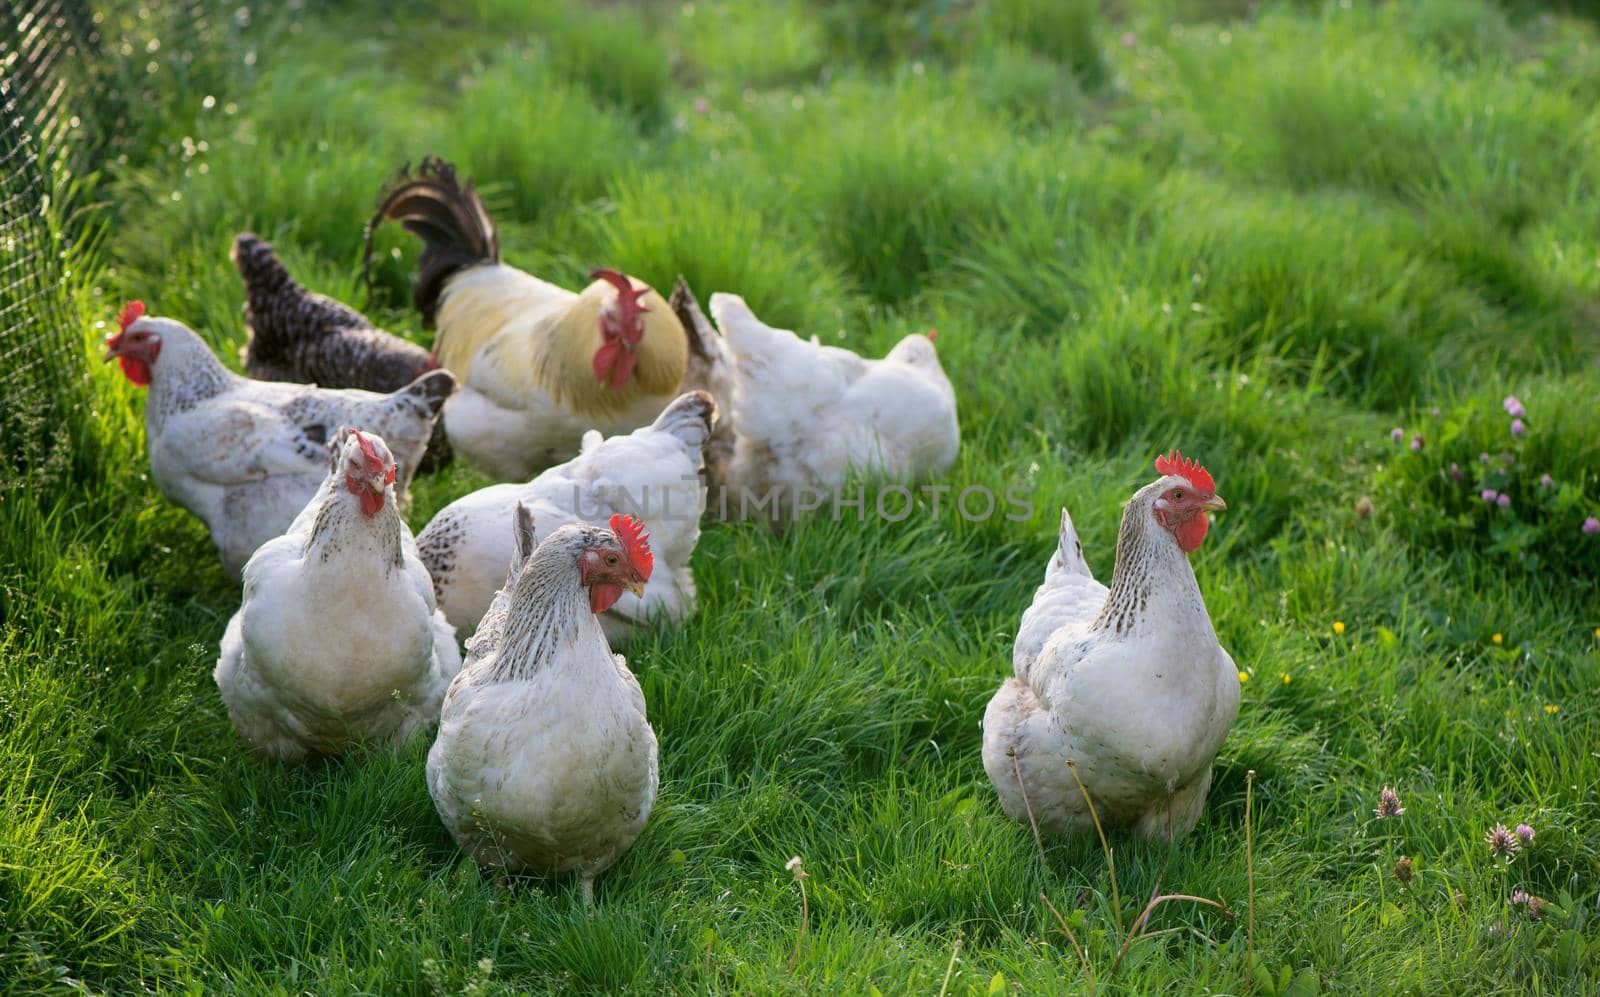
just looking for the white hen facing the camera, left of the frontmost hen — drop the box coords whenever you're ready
[213,430,461,762]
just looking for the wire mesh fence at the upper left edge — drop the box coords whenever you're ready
[0,0,98,470]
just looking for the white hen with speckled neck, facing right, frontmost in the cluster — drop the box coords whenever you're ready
[427,506,658,904]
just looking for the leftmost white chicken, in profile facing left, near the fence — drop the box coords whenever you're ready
[106,301,456,576]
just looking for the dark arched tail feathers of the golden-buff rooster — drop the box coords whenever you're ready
[362,155,499,328]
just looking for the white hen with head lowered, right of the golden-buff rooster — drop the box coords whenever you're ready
[697,294,962,519]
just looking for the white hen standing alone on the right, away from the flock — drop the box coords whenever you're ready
[984,451,1238,840]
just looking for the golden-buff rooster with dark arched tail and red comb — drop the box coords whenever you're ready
[368,158,688,480]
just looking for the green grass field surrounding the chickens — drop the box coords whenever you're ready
[0,0,1600,994]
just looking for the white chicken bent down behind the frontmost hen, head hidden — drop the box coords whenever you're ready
[418,390,717,643]
